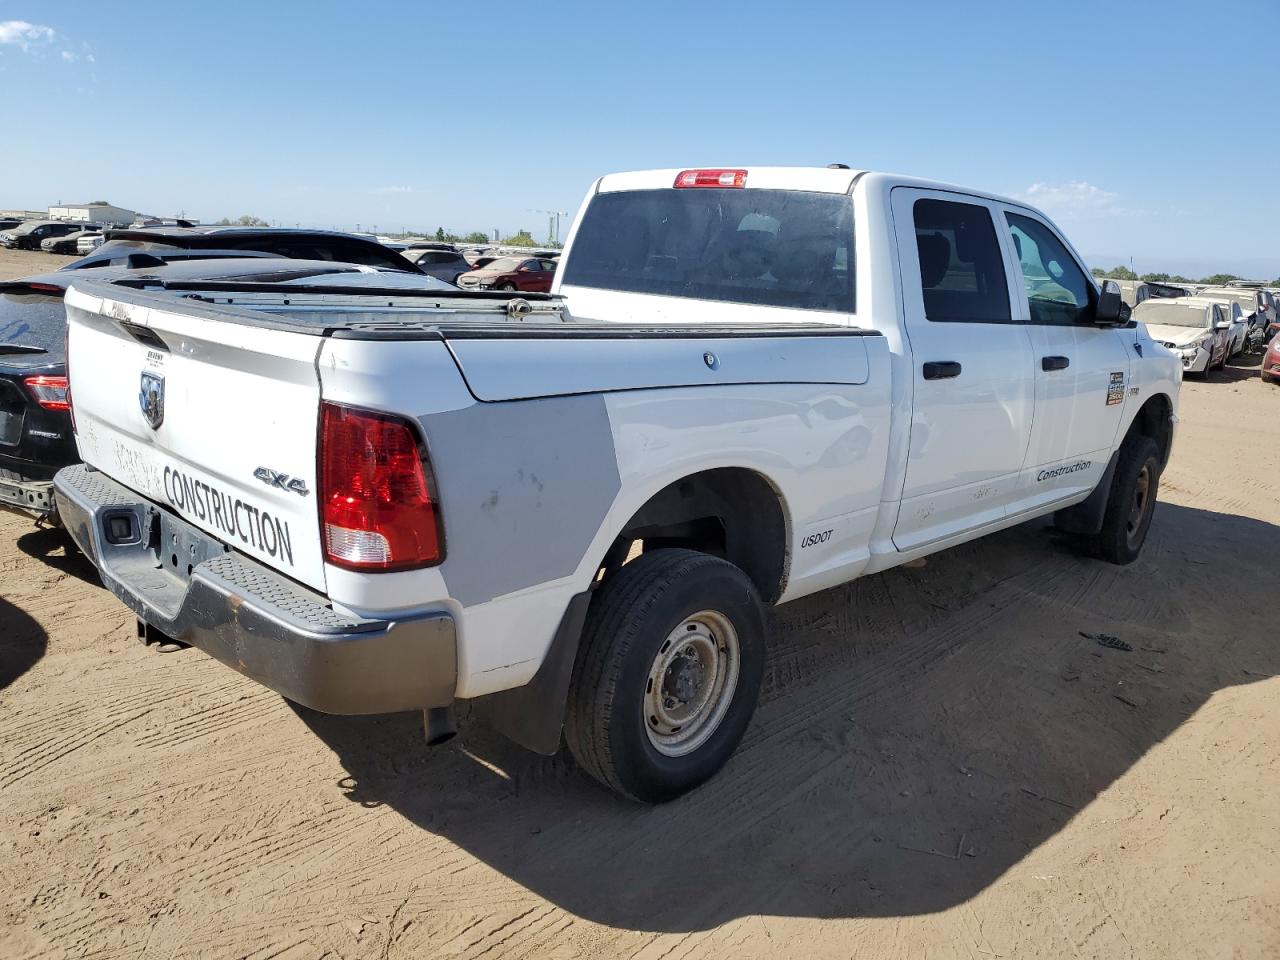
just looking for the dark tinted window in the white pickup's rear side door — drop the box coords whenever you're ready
[911,200,1012,324]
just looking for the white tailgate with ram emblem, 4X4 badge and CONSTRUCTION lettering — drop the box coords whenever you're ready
[65,285,325,590]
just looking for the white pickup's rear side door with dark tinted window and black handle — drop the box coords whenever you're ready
[892,187,1034,550]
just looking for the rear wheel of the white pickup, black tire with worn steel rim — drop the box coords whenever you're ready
[564,549,764,803]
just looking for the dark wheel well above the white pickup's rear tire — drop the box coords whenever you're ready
[600,467,787,603]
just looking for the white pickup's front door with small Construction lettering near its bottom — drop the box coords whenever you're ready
[997,205,1133,511]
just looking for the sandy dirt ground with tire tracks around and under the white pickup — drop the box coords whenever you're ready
[0,255,1280,960]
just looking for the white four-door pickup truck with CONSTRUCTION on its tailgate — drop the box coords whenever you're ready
[56,168,1181,801]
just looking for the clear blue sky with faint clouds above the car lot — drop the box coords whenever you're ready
[0,0,1280,278]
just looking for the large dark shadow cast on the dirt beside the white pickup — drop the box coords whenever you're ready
[297,503,1280,932]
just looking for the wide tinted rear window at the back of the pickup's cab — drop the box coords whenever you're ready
[565,188,855,312]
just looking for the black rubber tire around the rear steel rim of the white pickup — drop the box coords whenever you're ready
[564,548,764,804]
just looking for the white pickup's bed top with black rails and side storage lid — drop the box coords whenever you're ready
[67,280,881,401]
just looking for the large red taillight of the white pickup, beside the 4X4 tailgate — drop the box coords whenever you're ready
[320,403,443,570]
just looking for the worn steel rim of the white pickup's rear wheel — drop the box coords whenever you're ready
[643,611,741,756]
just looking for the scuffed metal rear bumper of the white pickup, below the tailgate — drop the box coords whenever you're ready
[54,465,457,714]
